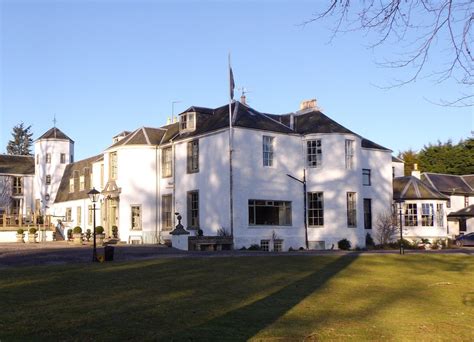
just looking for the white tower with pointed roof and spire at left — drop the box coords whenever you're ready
[34,127,74,214]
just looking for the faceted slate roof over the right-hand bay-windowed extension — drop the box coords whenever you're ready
[393,176,449,200]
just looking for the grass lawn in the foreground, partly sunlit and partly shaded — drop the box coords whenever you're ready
[0,255,474,342]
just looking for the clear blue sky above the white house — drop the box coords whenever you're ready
[0,0,474,160]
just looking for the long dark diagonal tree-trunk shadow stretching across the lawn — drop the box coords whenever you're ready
[164,253,358,341]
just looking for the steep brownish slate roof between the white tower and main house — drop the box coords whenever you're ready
[54,155,102,203]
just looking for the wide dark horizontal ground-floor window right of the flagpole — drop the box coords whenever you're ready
[249,199,291,226]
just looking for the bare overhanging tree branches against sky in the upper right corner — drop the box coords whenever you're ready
[304,0,474,107]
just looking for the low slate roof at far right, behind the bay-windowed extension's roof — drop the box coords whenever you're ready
[421,172,474,196]
